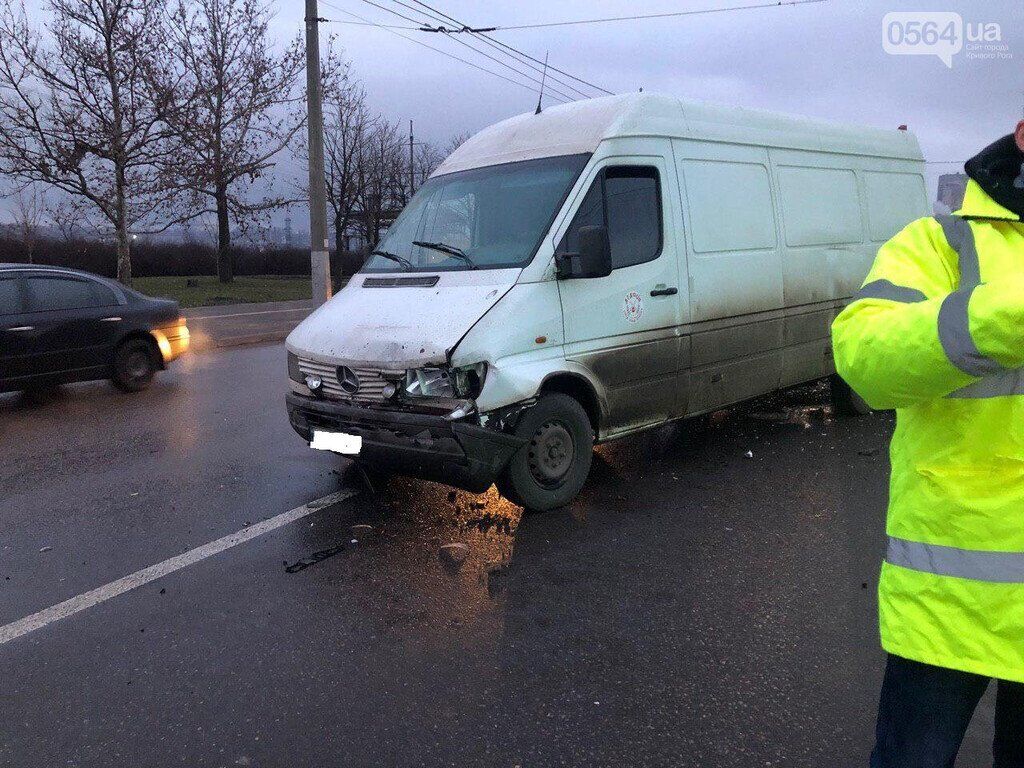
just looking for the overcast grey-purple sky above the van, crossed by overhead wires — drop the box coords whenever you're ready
[8,0,1024,228]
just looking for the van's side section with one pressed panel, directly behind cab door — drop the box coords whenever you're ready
[673,139,784,413]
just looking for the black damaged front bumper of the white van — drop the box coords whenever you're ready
[286,392,525,493]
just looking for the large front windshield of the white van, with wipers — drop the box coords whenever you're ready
[362,155,590,272]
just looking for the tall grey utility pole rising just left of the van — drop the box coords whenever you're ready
[306,0,332,304]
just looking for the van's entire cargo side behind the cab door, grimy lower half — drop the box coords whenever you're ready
[673,139,928,413]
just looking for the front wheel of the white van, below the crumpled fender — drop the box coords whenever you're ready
[498,393,594,512]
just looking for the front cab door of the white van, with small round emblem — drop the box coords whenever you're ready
[556,156,686,437]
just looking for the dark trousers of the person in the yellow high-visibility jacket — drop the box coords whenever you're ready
[870,655,1024,768]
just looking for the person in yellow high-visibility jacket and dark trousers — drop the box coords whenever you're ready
[833,122,1024,768]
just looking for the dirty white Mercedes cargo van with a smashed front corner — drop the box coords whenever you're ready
[287,94,928,510]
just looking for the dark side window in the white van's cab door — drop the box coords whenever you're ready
[557,166,663,269]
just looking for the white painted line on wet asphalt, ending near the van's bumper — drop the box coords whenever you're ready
[0,489,359,645]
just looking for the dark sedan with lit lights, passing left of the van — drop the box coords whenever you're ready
[0,264,188,392]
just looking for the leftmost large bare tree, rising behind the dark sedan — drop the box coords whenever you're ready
[0,0,172,285]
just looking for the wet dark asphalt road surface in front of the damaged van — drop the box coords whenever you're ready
[0,345,992,768]
